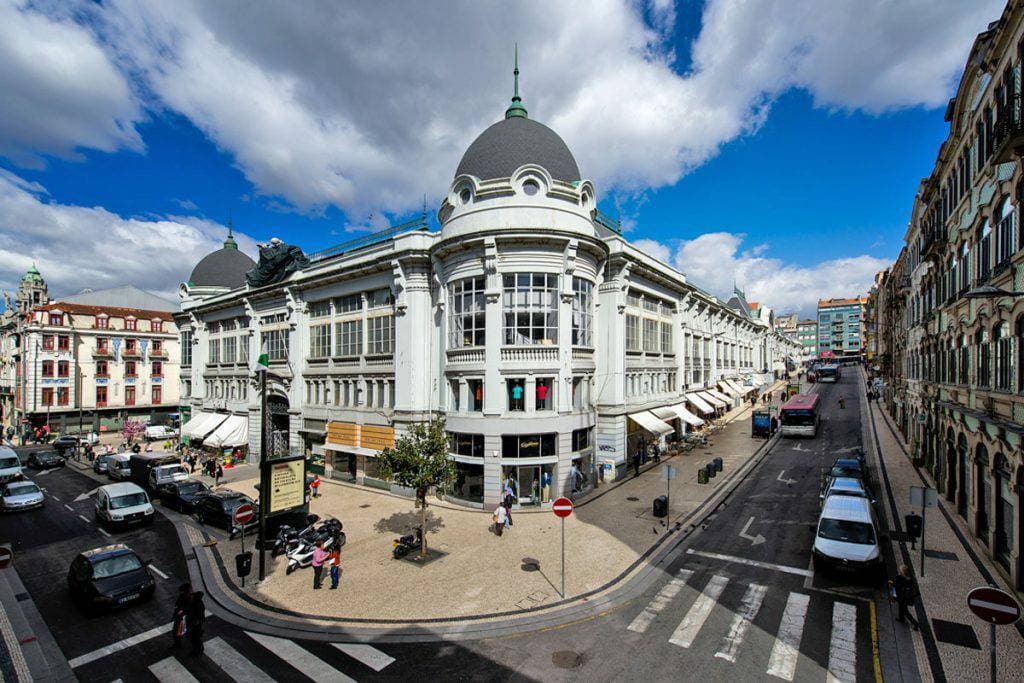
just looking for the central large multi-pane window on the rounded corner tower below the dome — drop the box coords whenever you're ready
[502,272,558,344]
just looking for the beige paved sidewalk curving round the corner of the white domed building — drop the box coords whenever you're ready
[184,383,782,629]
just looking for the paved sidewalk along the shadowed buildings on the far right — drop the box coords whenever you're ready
[865,370,1024,681]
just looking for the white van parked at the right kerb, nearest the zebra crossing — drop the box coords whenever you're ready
[813,496,885,577]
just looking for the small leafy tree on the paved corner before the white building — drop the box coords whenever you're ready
[377,418,456,557]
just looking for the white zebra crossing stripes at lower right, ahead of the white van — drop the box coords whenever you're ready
[627,569,858,683]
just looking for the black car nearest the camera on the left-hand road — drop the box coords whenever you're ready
[68,544,157,609]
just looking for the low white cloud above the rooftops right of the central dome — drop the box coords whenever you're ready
[667,232,889,315]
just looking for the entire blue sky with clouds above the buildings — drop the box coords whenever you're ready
[0,0,1002,315]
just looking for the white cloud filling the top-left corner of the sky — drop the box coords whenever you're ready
[0,0,142,167]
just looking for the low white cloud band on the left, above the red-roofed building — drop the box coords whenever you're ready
[0,173,257,300]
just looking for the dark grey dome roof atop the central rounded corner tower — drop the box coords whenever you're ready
[455,116,580,182]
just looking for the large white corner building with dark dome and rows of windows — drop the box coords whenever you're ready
[177,81,796,506]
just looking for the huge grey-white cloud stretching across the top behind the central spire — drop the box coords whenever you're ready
[9,0,1002,215]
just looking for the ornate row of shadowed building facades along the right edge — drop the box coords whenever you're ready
[878,3,1024,589]
